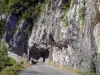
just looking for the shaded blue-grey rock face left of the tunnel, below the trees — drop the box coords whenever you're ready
[5,15,28,56]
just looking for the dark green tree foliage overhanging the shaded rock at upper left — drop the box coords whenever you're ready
[0,0,45,37]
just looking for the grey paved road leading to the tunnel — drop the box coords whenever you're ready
[19,62,77,75]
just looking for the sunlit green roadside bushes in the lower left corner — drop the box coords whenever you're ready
[0,42,23,75]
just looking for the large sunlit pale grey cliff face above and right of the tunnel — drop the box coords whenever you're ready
[29,0,98,69]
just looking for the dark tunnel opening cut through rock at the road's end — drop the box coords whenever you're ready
[29,47,49,64]
